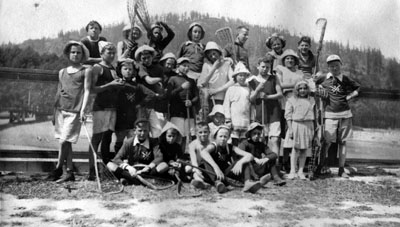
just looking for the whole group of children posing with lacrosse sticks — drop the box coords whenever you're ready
[48,18,360,193]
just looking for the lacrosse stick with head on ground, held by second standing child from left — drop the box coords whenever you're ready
[83,121,124,194]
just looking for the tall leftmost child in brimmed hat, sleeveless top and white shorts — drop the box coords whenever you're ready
[47,41,91,183]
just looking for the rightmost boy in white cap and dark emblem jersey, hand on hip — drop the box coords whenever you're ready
[316,55,360,178]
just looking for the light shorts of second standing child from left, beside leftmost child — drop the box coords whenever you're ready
[92,110,117,134]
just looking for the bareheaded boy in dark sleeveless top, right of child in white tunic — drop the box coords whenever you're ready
[248,55,283,158]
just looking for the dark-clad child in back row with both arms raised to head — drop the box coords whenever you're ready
[147,21,175,63]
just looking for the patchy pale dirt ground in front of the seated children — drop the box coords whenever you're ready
[0,167,400,227]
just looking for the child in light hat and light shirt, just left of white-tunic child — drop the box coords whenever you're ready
[197,42,235,113]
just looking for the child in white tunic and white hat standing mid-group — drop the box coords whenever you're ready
[223,62,253,146]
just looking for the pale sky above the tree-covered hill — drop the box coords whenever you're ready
[0,0,400,59]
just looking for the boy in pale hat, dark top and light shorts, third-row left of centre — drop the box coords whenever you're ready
[135,45,168,138]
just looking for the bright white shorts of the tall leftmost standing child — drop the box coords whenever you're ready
[55,110,82,143]
